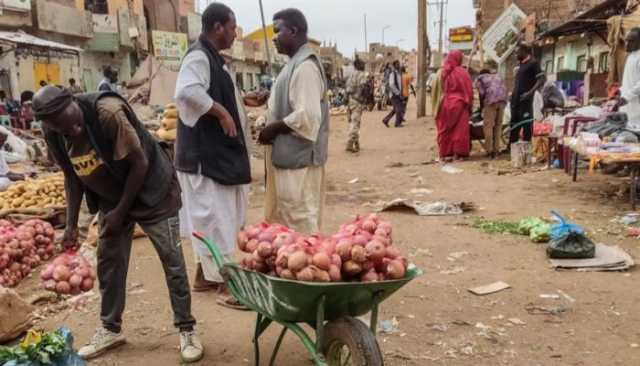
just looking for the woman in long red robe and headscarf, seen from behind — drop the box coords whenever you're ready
[434,51,473,161]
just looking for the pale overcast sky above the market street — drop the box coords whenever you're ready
[200,0,474,57]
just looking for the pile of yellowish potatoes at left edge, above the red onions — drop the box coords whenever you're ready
[0,174,66,210]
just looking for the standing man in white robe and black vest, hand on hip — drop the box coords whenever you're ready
[175,3,251,302]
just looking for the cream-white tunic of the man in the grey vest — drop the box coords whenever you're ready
[265,60,326,233]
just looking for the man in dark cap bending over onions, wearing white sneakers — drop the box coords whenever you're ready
[33,86,203,362]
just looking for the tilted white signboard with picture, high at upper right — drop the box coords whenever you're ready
[482,4,527,64]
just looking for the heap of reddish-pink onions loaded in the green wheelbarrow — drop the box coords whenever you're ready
[238,214,408,282]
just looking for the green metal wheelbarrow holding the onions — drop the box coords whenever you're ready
[193,232,422,366]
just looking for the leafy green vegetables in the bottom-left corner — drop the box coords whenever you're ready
[0,330,67,365]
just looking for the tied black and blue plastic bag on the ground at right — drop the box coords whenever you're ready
[547,212,596,259]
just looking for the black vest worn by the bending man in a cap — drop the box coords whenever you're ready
[45,92,175,213]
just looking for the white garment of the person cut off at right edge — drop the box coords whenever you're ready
[620,51,640,131]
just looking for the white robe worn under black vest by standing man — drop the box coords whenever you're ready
[175,51,249,282]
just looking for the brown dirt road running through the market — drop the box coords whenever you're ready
[25,101,640,366]
